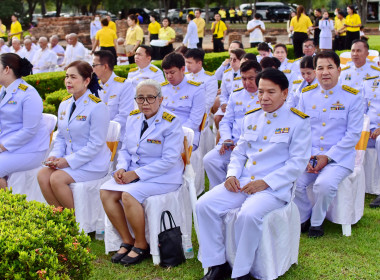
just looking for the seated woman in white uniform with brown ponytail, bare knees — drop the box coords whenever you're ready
[38,61,111,209]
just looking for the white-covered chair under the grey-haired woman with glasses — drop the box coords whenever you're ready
[104,127,196,265]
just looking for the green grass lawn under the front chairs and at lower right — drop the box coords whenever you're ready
[90,192,380,280]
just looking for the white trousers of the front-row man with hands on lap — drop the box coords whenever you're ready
[196,183,285,278]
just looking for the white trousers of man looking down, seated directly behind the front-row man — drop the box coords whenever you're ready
[203,146,231,190]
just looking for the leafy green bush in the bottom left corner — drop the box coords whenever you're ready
[0,190,95,279]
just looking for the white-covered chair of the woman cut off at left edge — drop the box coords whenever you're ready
[8,114,57,203]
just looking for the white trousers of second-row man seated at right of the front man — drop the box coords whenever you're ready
[294,163,352,226]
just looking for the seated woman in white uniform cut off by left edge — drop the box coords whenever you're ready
[0,53,49,188]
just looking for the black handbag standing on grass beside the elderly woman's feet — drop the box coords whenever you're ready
[158,211,186,267]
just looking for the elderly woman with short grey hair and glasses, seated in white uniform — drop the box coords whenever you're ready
[100,79,184,265]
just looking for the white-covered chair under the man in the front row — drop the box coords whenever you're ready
[224,186,301,279]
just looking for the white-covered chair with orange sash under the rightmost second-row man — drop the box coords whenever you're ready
[308,115,370,236]
